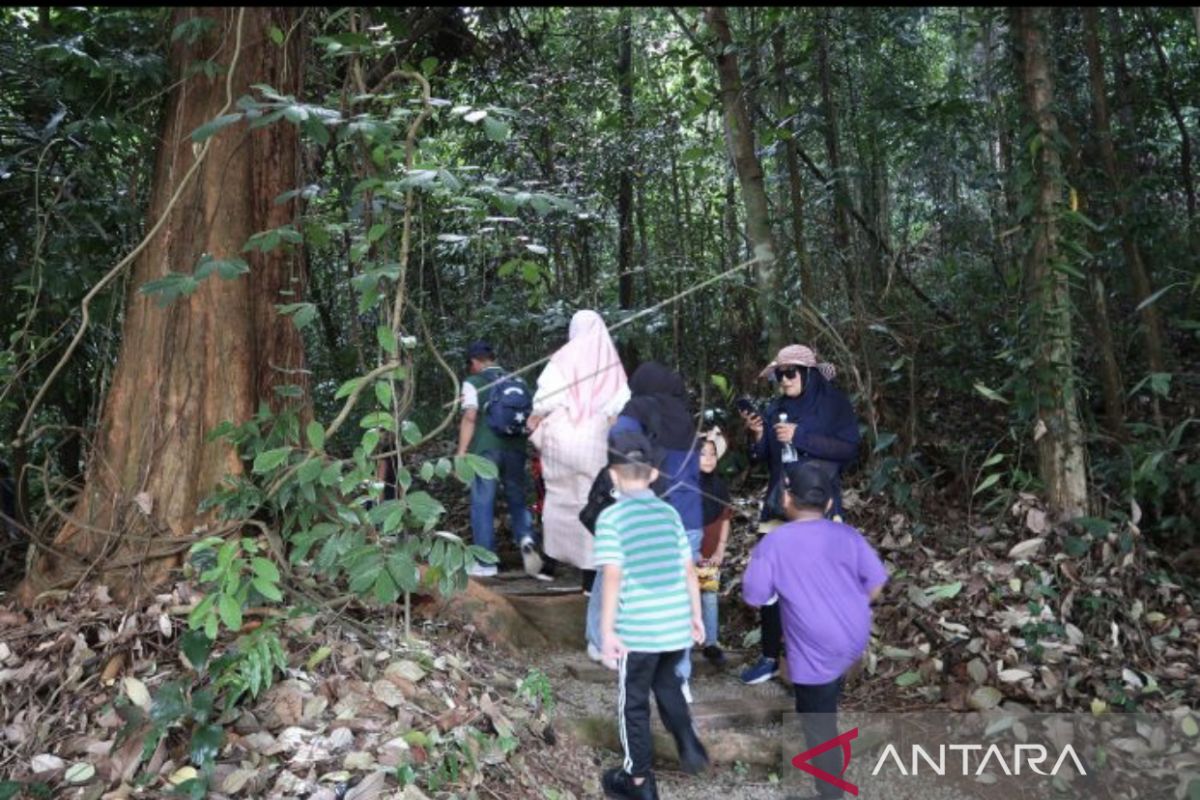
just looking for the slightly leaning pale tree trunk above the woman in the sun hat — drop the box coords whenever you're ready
[704,6,786,355]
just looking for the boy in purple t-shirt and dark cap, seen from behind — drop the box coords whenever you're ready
[742,462,888,798]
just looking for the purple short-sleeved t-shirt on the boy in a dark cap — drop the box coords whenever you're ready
[742,519,888,685]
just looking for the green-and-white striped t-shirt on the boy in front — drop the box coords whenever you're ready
[594,489,692,652]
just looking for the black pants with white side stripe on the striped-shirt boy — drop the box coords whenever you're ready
[617,650,701,777]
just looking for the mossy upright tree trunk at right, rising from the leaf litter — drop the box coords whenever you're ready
[1013,8,1087,517]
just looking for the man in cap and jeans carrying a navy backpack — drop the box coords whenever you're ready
[456,341,541,578]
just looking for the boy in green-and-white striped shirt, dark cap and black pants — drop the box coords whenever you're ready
[594,432,708,800]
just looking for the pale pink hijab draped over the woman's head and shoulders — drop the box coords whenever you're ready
[550,309,628,425]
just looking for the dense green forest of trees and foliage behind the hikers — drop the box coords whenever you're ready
[0,6,1200,796]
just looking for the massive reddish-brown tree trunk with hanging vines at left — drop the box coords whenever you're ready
[20,8,306,601]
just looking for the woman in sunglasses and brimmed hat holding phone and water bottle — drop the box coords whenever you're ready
[742,344,860,684]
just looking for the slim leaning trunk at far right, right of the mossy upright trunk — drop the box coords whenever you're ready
[1082,7,1166,372]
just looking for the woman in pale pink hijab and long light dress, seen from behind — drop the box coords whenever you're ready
[529,309,630,578]
